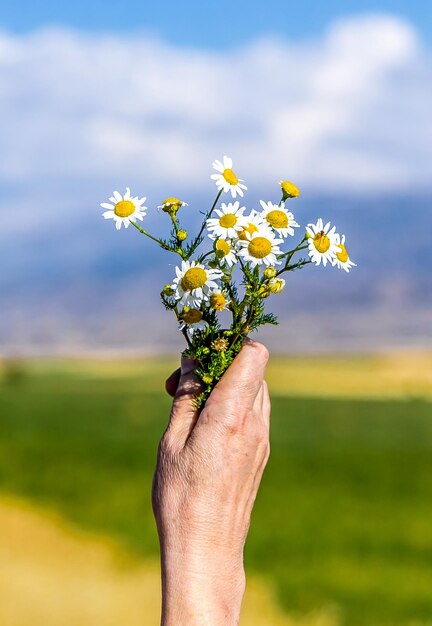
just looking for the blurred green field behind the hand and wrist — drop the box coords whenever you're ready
[0,361,432,626]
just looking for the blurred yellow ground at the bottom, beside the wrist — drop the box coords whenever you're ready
[0,497,336,626]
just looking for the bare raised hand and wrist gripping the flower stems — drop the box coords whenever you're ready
[153,339,270,626]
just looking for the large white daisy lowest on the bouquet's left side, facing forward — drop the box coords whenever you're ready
[171,261,222,307]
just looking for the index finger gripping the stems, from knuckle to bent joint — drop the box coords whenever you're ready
[206,339,269,410]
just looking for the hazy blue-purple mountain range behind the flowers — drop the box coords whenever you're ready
[0,195,432,354]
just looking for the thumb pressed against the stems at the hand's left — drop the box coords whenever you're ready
[166,357,201,447]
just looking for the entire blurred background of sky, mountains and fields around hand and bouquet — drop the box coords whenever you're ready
[0,0,432,626]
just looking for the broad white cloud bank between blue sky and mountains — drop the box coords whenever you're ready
[0,10,432,210]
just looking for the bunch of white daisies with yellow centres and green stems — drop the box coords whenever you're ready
[101,156,355,407]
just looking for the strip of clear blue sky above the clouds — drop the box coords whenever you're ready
[0,0,432,49]
